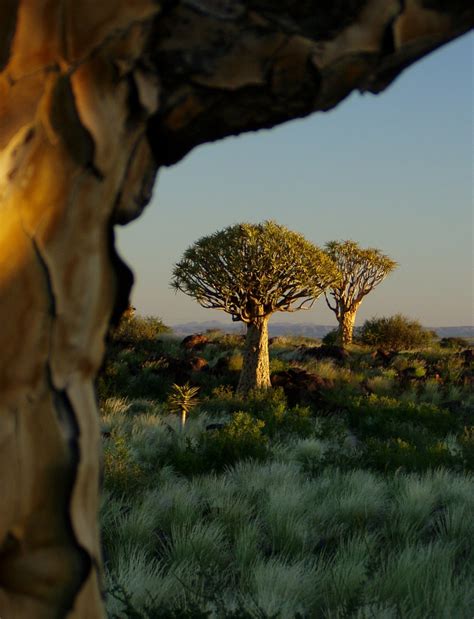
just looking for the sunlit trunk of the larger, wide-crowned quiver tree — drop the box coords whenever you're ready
[237,317,271,395]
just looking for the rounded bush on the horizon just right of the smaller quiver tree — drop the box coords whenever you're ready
[357,314,434,350]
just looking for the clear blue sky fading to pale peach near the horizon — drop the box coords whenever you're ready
[118,35,474,326]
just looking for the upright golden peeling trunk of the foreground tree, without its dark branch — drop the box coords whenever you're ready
[0,2,156,619]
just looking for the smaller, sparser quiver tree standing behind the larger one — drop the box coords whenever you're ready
[325,241,397,346]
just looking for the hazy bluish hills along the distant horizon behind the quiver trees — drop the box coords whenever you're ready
[172,320,474,339]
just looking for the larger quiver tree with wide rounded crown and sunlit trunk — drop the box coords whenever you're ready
[172,221,338,395]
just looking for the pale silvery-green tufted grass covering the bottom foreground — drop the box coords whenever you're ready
[102,446,474,619]
